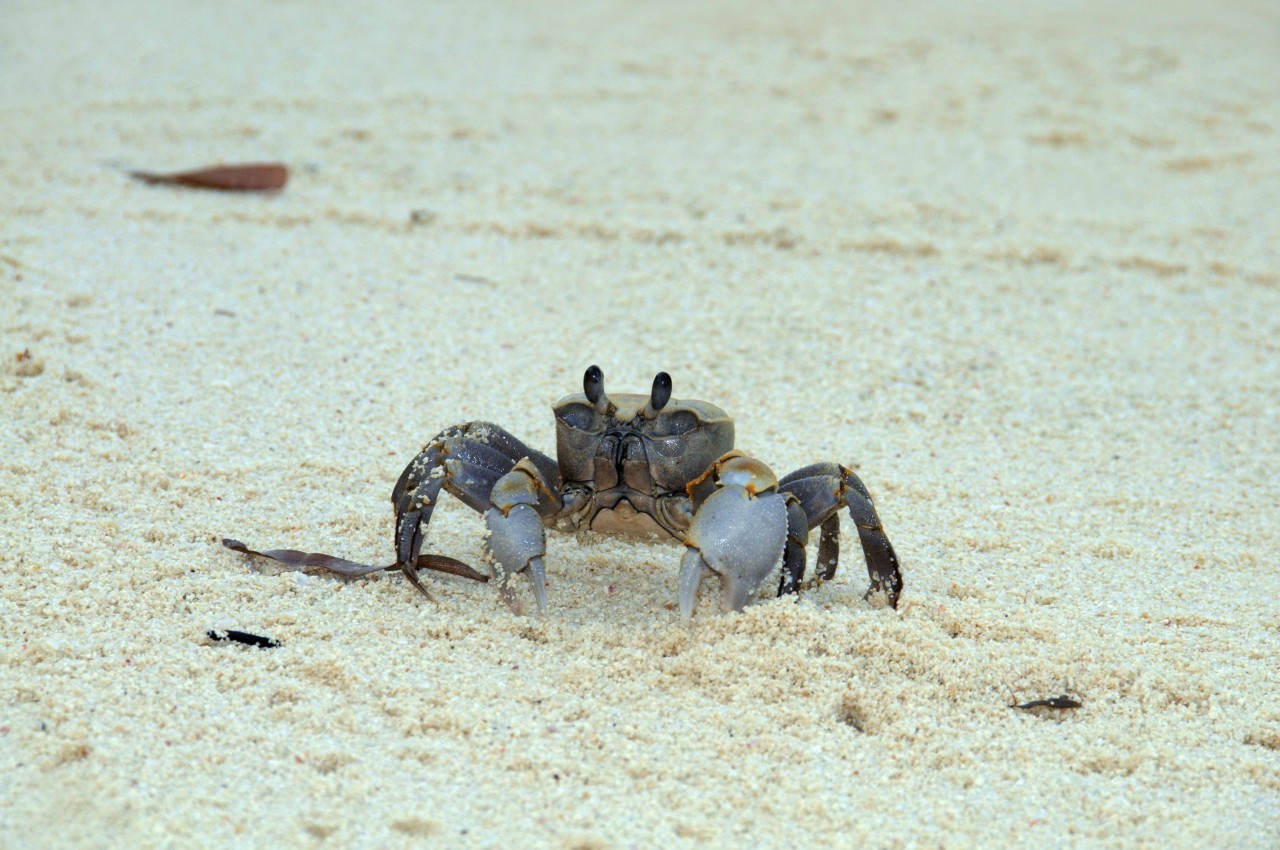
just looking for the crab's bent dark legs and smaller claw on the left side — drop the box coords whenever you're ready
[392,422,561,609]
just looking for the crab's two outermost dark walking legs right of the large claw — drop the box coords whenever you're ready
[778,463,902,608]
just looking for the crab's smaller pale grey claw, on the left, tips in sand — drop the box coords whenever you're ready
[484,461,548,614]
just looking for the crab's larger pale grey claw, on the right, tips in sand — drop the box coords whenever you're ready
[680,452,787,622]
